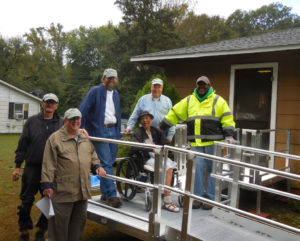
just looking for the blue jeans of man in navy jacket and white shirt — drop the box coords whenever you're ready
[93,127,118,199]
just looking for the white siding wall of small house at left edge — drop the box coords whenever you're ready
[0,83,40,134]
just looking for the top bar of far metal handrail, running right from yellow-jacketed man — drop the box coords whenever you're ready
[215,142,300,161]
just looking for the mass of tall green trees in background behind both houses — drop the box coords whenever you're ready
[0,0,300,118]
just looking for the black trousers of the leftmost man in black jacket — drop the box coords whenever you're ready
[18,166,48,231]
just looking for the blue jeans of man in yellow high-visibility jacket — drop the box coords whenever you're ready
[191,145,216,200]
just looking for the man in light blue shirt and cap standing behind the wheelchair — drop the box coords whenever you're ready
[124,78,175,142]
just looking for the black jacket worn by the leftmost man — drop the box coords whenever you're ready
[15,111,63,168]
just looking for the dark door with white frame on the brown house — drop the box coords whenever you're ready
[229,62,278,168]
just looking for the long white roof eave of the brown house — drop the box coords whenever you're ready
[130,44,300,62]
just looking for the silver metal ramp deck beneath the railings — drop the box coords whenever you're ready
[88,194,299,241]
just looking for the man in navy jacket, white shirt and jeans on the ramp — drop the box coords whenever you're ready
[80,69,122,208]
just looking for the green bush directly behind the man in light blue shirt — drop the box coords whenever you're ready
[131,74,180,113]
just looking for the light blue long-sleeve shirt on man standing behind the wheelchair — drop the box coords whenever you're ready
[127,94,175,140]
